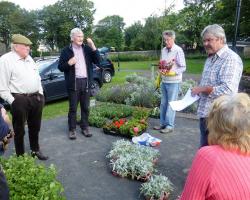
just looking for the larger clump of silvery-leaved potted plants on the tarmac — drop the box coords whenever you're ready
[107,140,159,181]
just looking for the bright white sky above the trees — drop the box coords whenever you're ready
[3,0,183,27]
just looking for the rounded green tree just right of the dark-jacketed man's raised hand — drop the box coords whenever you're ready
[94,15,125,50]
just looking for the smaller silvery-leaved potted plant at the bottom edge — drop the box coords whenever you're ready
[140,175,173,200]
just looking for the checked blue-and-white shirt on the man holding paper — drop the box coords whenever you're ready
[197,45,243,118]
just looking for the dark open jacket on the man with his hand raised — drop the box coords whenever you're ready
[58,44,100,90]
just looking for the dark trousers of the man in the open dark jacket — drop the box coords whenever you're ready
[68,78,89,131]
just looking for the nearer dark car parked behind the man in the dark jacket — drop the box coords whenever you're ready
[0,57,103,106]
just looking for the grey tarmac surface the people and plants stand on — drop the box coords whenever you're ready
[5,113,199,200]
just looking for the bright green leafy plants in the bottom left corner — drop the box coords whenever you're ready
[0,155,66,200]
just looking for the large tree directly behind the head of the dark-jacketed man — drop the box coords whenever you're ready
[40,0,95,49]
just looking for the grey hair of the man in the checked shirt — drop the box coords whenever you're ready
[201,24,227,44]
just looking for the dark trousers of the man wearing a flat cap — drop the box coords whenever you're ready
[11,94,44,155]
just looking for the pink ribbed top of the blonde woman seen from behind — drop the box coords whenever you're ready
[180,145,250,200]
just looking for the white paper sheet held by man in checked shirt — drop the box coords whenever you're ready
[169,88,200,111]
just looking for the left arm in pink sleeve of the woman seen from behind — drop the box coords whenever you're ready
[180,148,212,200]
